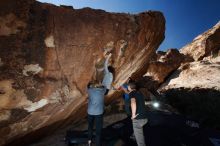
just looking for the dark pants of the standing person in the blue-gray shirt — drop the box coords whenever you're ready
[88,115,103,146]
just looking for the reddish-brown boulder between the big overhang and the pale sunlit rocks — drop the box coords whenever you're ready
[145,49,184,84]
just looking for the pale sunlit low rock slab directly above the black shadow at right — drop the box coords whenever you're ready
[160,61,220,91]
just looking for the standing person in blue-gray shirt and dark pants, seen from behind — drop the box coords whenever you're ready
[87,82,106,146]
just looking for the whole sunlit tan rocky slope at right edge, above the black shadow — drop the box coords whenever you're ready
[161,23,220,91]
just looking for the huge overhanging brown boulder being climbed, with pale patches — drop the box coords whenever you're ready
[0,0,165,145]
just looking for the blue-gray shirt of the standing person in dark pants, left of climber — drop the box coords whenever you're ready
[87,87,106,115]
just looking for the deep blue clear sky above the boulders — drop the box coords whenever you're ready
[38,0,220,50]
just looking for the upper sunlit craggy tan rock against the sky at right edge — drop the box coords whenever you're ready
[180,22,220,61]
